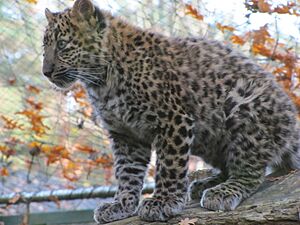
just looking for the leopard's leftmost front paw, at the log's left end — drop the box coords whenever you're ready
[94,201,136,224]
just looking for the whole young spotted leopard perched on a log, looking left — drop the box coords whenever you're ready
[43,0,300,224]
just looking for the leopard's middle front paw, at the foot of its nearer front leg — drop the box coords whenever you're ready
[138,197,185,221]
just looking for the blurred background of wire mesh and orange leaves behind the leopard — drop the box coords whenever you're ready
[0,0,300,217]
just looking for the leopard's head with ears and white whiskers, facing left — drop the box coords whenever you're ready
[43,0,107,89]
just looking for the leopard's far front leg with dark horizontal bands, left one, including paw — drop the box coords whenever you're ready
[94,135,151,224]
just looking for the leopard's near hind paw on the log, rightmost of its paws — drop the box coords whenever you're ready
[200,184,243,211]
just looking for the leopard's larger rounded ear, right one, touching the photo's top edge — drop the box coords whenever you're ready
[72,0,95,19]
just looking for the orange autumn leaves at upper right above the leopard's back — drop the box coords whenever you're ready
[186,0,300,109]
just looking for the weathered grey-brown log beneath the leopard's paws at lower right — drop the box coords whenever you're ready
[108,170,300,225]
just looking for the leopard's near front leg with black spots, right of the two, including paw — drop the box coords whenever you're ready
[138,114,193,221]
